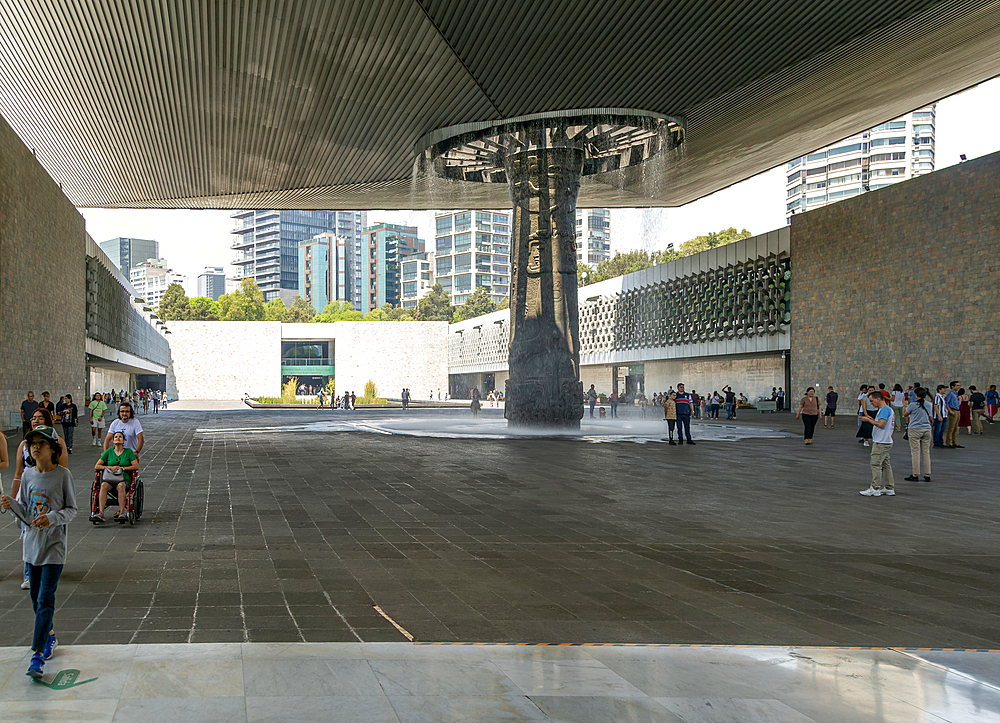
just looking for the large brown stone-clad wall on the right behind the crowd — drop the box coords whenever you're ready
[791,153,1000,396]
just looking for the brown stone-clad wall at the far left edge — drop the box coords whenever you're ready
[0,114,86,428]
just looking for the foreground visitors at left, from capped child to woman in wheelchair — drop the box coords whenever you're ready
[0,391,144,679]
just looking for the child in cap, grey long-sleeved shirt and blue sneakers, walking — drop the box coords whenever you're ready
[0,427,77,679]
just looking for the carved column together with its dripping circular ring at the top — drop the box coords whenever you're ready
[414,114,684,429]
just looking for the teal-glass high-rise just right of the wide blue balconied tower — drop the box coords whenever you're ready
[355,223,424,314]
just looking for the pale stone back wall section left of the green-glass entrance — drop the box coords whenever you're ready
[167,321,281,400]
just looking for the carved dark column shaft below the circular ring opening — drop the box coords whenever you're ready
[504,147,584,428]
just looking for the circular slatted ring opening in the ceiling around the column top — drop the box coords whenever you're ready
[417,111,684,183]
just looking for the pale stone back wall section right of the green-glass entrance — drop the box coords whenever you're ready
[333,321,448,399]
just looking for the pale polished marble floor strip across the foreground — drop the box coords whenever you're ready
[0,643,1000,723]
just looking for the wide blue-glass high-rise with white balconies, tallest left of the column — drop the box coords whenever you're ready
[232,211,367,306]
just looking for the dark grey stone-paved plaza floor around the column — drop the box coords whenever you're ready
[0,407,1000,649]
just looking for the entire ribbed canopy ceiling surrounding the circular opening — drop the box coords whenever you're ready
[0,0,1000,209]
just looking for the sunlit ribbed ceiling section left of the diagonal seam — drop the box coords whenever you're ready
[0,0,497,205]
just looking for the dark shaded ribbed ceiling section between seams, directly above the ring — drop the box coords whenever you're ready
[421,0,937,116]
